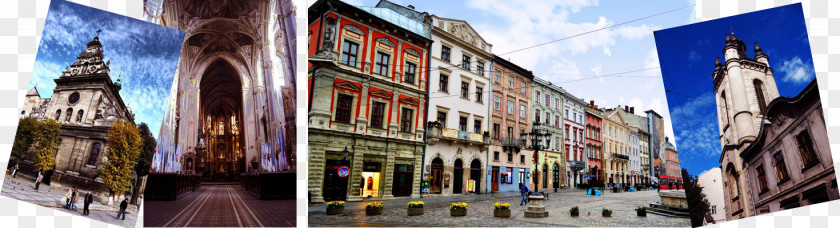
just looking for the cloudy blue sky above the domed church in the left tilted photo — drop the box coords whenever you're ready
[29,0,184,137]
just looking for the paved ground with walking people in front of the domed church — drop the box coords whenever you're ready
[0,174,138,227]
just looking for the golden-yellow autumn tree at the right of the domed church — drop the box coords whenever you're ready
[99,119,141,198]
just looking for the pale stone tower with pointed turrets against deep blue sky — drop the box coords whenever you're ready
[712,33,779,219]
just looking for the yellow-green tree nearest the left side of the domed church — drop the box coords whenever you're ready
[33,119,61,171]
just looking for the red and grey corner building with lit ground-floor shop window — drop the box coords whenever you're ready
[308,0,432,202]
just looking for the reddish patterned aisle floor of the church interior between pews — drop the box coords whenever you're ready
[143,185,296,227]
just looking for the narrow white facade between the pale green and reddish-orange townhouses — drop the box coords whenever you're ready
[563,93,587,188]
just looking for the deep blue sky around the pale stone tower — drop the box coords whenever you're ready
[655,4,815,175]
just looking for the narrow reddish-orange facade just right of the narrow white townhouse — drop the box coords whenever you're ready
[586,101,604,183]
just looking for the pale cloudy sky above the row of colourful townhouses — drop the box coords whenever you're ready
[316,0,695,142]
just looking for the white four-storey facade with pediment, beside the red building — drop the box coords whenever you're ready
[426,14,492,195]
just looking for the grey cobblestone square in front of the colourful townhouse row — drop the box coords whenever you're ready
[309,191,691,227]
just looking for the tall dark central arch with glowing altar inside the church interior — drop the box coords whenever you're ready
[197,59,246,181]
